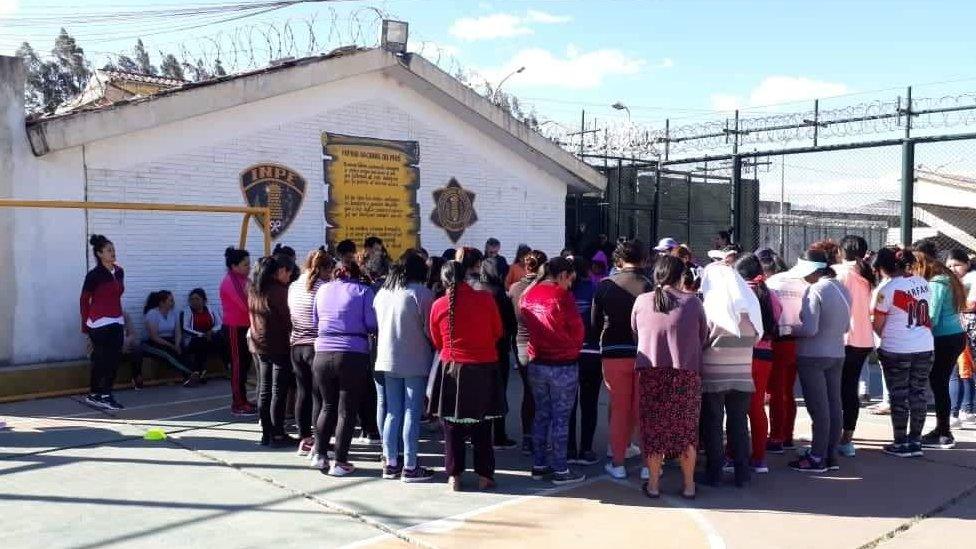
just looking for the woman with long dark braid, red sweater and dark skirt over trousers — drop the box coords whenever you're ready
[428,261,504,491]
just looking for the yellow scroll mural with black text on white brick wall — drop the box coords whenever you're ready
[322,132,420,257]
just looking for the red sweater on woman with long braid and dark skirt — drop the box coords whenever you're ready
[430,282,500,364]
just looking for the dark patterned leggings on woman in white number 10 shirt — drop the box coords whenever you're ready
[878,349,933,443]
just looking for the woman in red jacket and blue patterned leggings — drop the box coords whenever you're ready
[519,257,586,485]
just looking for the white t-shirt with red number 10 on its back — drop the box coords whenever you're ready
[874,276,934,353]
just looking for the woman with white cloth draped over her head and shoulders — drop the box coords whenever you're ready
[701,262,763,486]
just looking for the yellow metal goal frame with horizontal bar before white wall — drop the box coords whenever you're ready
[0,198,271,255]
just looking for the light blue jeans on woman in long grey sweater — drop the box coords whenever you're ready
[377,373,427,469]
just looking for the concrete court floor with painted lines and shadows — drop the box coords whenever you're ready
[0,376,976,549]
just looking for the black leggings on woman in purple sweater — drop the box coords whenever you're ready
[312,351,376,463]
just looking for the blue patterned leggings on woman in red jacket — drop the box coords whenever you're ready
[529,362,579,472]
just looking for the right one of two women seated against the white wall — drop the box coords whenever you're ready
[180,288,230,383]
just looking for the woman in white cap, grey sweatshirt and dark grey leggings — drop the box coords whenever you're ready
[790,250,851,473]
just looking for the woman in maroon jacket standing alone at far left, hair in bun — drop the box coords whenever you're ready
[81,234,125,410]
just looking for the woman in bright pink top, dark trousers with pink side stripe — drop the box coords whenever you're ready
[220,247,257,416]
